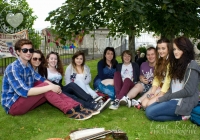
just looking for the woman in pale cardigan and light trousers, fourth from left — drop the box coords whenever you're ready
[65,51,99,99]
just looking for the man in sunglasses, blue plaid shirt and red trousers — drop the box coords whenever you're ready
[1,39,92,120]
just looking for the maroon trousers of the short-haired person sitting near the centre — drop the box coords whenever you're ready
[114,71,134,100]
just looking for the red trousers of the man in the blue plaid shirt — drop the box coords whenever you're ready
[9,82,80,116]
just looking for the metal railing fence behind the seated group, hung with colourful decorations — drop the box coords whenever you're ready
[0,30,127,75]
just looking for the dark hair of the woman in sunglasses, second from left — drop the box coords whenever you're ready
[29,50,47,78]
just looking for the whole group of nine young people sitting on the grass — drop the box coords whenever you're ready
[1,37,200,121]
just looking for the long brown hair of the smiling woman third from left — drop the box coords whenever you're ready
[45,52,64,76]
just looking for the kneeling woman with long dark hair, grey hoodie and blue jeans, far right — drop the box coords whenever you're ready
[146,37,200,121]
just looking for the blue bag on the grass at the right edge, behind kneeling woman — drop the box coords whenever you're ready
[190,101,200,126]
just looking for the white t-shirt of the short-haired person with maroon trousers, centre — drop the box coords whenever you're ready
[121,63,133,81]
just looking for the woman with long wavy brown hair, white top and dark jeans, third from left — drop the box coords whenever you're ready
[45,52,105,113]
